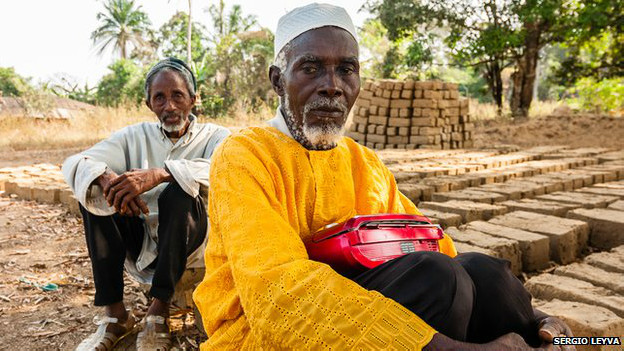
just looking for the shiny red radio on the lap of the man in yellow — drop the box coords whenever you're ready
[306,214,444,277]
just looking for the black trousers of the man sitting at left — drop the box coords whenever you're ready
[80,182,208,306]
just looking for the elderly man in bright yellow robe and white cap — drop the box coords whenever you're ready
[194,4,569,351]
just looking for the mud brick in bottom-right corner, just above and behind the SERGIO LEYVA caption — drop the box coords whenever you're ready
[532,299,624,351]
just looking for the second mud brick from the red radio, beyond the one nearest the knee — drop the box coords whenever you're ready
[467,221,550,271]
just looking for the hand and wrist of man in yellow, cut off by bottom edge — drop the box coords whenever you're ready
[423,333,566,351]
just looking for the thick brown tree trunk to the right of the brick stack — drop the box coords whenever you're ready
[510,23,541,119]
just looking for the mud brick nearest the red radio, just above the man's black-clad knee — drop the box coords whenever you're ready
[445,227,522,275]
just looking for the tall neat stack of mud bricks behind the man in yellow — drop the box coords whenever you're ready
[347,80,474,150]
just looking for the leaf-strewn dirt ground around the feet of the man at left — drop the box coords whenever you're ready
[0,197,201,351]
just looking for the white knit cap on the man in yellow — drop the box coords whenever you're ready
[274,3,357,57]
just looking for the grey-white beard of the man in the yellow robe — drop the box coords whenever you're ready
[283,94,349,150]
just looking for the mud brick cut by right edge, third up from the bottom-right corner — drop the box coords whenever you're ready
[554,263,624,296]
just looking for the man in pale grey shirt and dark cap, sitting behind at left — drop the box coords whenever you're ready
[63,58,230,351]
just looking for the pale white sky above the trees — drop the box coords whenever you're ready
[0,0,369,86]
